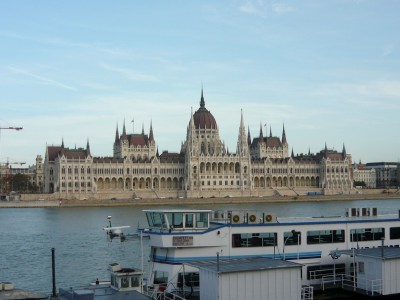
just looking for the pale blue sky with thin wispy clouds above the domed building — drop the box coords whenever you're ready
[0,0,400,167]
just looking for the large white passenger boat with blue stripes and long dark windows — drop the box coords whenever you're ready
[144,208,400,294]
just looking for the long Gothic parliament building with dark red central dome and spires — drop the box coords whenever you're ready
[37,91,353,199]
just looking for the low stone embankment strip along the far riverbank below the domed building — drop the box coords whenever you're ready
[0,191,400,208]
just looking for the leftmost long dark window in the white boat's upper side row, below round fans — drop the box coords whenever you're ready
[232,232,276,248]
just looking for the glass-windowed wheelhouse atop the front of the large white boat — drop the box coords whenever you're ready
[144,209,212,232]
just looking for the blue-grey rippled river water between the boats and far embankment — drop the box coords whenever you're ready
[0,199,400,294]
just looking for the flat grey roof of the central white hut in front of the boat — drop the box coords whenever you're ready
[185,257,302,273]
